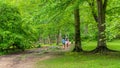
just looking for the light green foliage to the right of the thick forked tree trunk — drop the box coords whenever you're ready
[106,0,120,41]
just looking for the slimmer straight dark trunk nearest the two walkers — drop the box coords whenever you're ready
[73,5,83,52]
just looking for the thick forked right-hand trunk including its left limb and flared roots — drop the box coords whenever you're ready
[89,0,114,52]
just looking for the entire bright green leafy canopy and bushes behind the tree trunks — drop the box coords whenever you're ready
[0,0,120,52]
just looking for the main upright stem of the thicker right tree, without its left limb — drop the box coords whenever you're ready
[94,0,109,52]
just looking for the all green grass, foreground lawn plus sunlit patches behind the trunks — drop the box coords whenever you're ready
[36,40,120,68]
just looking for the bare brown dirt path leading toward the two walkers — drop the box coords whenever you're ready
[0,47,71,68]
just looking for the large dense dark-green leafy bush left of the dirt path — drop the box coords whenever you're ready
[0,3,35,50]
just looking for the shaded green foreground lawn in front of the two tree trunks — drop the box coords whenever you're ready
[36,53,120,68]
